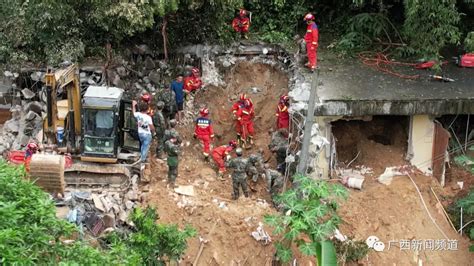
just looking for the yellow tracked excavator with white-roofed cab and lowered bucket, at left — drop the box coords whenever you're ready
[30,64,145,191]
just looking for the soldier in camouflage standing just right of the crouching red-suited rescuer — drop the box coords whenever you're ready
[226,148,249,200]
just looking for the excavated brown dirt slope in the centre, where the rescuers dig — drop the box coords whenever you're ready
[147,62,288,265]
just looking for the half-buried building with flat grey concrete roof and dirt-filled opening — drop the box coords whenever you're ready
[304,60,474,185]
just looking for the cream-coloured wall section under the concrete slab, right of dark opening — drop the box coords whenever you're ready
[407,115,434,175]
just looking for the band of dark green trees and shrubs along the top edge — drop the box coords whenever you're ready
[0,0,474,64]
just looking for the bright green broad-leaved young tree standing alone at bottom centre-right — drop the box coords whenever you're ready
[265,175,348,265]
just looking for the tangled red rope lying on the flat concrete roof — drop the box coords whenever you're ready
[358,52,420,79]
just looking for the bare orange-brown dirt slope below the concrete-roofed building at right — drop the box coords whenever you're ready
[340,175,474,265]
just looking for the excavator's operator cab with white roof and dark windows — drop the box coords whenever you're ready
[81,86,123,163]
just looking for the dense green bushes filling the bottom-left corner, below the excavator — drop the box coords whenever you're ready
[0,161,195,265]
